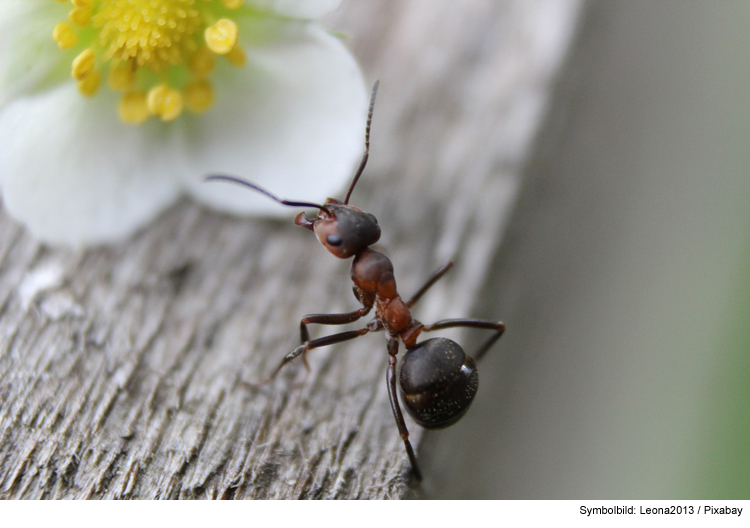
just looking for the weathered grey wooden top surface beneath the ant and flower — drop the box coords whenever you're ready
[0,0,581,498]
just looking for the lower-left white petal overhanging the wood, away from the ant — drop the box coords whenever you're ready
[0,82,184,245]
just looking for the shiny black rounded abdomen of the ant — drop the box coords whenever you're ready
[399,337,479,429]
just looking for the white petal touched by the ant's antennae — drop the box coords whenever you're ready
[186,21,367,215]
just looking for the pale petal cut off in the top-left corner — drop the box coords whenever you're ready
[0,0,70,108]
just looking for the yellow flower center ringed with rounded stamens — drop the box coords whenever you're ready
[52,0,246,124]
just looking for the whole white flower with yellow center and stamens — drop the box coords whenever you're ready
[0,0,367,245]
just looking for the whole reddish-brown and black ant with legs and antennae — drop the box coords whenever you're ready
[206,81,505,480]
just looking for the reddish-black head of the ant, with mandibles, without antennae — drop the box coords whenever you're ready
[294,198,380,258]
